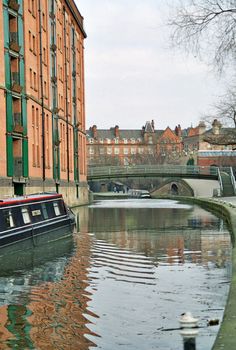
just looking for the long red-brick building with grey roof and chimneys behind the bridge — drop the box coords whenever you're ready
[87,120,183,166]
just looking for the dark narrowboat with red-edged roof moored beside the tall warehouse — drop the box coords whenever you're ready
[0,193,75,252]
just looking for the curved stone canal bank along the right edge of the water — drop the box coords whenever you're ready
[177,197,236,350]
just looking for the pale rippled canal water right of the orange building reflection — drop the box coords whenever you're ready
[81,200,231,350]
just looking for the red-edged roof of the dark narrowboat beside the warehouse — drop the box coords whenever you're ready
[0,192,62,207]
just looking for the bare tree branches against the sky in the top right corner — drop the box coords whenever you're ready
[169,0,236,73]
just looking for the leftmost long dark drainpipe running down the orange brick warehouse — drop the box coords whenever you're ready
[38,0,45,187]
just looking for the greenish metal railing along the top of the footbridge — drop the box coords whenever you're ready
[88,165,218,177]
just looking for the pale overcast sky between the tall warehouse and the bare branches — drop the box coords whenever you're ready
[75,0,227,129]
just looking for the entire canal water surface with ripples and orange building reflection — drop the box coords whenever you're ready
[0,199,231,350]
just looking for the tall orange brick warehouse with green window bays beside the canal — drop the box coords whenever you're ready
[0,0,88,205]
